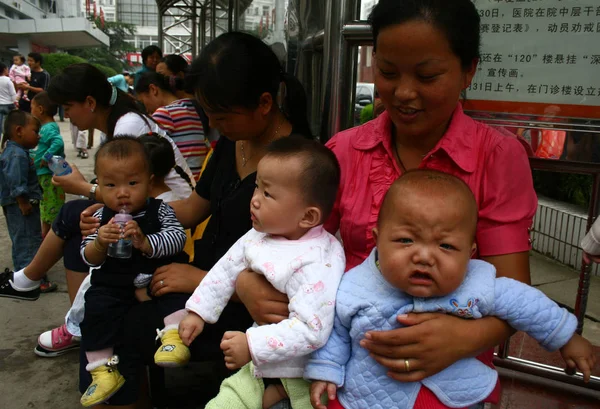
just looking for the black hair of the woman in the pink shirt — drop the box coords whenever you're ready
[369,0,481,69]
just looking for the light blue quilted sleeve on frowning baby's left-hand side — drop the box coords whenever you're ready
[304,315,352,388]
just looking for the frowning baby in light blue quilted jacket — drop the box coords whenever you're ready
[304,170,596,409]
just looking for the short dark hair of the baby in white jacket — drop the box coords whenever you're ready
[265,134,341,222]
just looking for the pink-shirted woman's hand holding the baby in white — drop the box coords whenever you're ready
[235,270,290,325]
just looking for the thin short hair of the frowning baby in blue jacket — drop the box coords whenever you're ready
[377,169,479,238]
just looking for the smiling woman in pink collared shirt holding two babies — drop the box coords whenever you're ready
[237,0,537,400]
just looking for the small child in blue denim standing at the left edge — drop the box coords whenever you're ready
[0,110,42,270]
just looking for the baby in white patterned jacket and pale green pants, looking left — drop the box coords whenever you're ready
[154,136,345,409]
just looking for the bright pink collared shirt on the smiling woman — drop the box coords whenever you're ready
[325,104,537,270]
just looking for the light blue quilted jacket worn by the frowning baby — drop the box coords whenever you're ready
[304,250,577,409]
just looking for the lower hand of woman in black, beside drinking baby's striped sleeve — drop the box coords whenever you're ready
[150,263,206,297]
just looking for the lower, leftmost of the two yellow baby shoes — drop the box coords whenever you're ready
[81,355,125,407]
